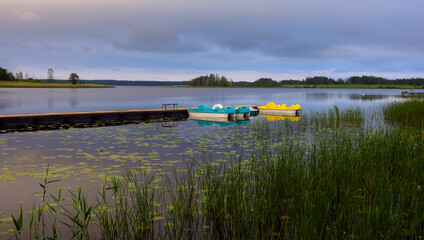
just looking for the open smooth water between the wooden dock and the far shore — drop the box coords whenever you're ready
[0,86,401,114]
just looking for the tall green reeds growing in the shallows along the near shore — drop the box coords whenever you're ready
[6,107,424,239]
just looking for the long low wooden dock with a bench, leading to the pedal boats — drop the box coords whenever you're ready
[0,104,256,133]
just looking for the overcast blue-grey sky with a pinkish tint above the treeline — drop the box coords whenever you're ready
[0,0,424,81]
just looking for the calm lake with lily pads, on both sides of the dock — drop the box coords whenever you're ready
[0,87,410,235]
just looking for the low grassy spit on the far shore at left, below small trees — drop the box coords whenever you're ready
[0,81,114,88]
